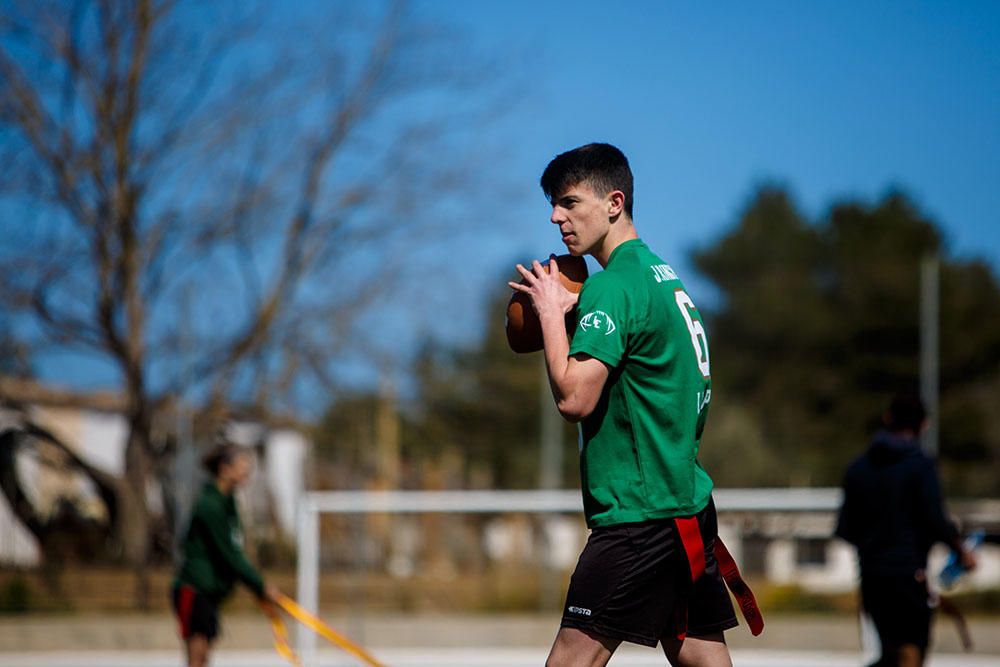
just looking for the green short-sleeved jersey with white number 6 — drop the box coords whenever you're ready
[570,239,712,527]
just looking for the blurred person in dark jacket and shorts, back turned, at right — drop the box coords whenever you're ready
[836,394,976,667]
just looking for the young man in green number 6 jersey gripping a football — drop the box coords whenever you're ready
[510,144,737,667]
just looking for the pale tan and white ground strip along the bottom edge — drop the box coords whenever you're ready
[0,613,1000,667]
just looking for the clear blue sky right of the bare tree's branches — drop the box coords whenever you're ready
[417,0,1000,308]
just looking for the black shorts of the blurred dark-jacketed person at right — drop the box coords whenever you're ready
[861,575,933,649]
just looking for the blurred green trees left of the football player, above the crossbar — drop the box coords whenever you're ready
[314,277,577,489]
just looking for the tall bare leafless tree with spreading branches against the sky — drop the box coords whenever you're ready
[0,0,516,604]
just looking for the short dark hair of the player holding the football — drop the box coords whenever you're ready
[541,144,632,218]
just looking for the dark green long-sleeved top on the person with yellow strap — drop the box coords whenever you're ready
[174,482,264,602]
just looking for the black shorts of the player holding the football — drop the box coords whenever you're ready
[562,502,738,646]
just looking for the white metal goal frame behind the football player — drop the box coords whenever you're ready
[296,488,841,667]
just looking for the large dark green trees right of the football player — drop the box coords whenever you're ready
[694,187,1000,493]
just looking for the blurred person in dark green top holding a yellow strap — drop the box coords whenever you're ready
[172,443,280,667]
